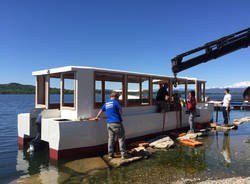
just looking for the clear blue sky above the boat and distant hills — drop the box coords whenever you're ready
[0,0,250,86]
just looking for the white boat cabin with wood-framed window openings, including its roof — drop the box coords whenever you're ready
[32,66,206,120]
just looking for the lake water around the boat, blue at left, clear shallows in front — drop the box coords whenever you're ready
[0,95,250,184]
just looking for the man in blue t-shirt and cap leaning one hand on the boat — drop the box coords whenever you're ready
[95,92,127,159]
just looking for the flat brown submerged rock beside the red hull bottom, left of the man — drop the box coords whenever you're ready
[65,157,108,174]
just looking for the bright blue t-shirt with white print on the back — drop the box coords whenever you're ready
[102,100,122,123]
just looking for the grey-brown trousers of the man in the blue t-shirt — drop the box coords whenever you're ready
[107,122,126,156]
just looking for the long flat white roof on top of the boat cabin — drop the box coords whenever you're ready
[32,66,206,82]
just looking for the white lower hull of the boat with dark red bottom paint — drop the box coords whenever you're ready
[18,105,213,160]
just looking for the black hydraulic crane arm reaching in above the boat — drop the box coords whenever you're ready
[171,28,250,76]
